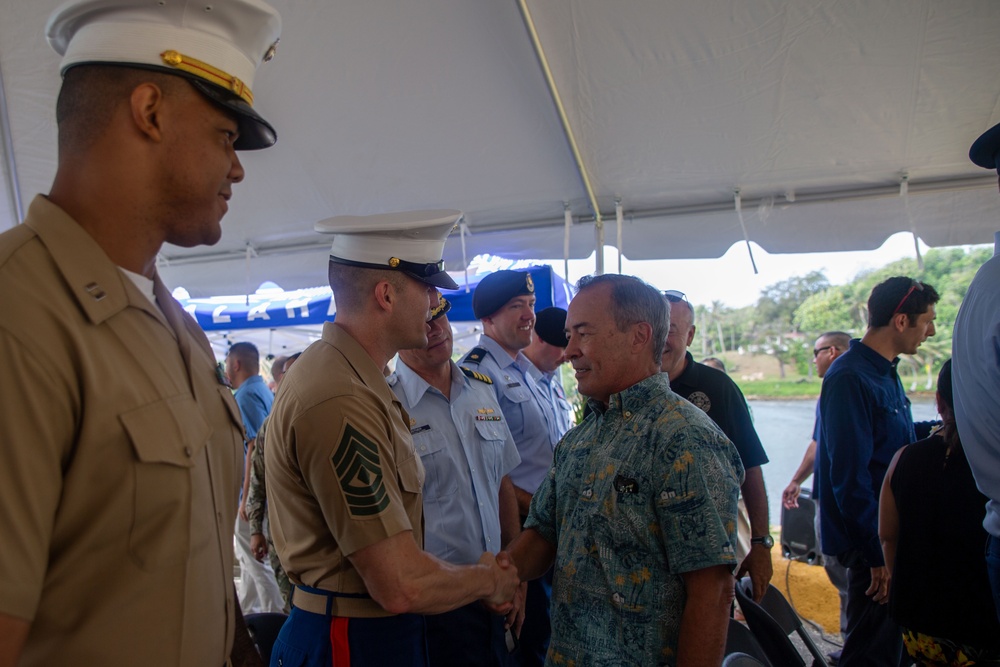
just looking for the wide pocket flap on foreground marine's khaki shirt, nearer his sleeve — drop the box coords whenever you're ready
[118,397,212,468]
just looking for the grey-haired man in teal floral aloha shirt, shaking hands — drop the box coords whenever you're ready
[510,275,743,667]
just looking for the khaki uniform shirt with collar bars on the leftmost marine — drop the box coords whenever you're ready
[0,197,243,667]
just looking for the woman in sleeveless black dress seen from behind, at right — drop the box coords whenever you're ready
[879,360,1000,665]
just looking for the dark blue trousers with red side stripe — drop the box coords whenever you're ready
[271,607,428,667]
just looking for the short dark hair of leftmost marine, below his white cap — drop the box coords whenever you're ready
[56,64,190,152]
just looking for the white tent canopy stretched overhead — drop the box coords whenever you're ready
[0,0,1000,296]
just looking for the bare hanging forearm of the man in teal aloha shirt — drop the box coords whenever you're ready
[677,565,733,667]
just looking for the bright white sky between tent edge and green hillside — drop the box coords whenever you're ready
[524,232,992,308]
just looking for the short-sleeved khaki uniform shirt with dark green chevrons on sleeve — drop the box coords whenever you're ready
[264,322,424,618]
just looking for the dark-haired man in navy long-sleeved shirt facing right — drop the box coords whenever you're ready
[816,276,938,667]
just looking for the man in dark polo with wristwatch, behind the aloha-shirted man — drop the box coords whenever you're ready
[661,290,774,600]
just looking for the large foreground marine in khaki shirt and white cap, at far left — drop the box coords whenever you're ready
[0,0,280,667]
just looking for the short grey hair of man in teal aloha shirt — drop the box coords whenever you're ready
[576,273,670,363]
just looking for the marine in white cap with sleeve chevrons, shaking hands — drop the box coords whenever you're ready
[264,211,518,667]
